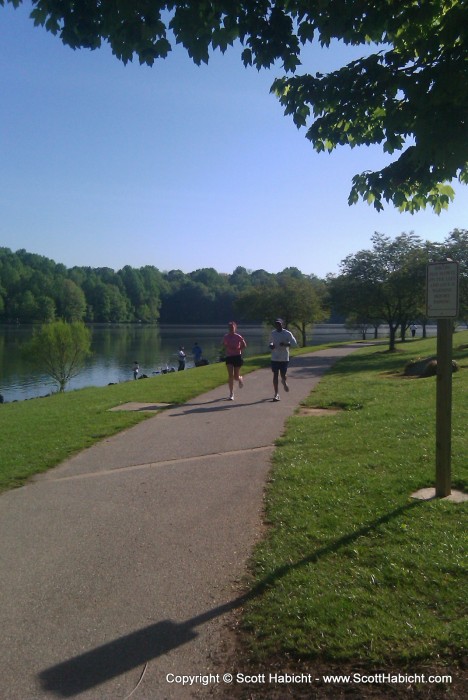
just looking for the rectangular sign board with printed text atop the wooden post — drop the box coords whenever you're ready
[426,262,458,318]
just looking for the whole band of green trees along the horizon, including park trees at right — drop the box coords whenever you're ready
[0,229,468,349]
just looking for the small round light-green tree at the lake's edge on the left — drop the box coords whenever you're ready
[23,320,91,391]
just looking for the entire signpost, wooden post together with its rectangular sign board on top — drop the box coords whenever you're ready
[426,261,459,498]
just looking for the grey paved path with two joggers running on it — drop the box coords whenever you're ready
[0,345,356,700]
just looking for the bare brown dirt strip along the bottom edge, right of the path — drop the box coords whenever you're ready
[207,624,468,700]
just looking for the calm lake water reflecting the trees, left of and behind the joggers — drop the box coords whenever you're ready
[0,324,434,402]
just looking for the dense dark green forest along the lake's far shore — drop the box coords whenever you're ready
[0,248,325,324]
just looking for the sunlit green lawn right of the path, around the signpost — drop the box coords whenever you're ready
[243,333,468,666]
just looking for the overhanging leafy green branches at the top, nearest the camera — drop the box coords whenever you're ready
[0,0,468,212]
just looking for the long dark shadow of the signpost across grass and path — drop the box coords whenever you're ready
[39,501,423,698]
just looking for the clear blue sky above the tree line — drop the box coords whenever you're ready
[0,3,468,277]
